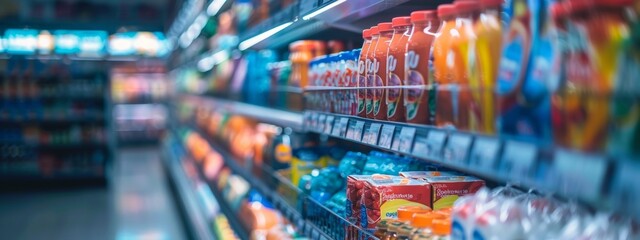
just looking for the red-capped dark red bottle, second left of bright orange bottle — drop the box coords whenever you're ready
[385,17,411,122]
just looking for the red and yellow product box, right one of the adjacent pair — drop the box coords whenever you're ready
[426,176,485,210]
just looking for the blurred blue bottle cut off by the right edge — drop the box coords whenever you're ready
[600,1,640,155]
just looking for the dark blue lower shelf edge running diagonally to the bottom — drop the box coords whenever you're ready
[192,125,376,240]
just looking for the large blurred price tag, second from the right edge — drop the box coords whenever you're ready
[552,150,608,203]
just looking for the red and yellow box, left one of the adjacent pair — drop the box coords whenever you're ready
[360,175,431,230]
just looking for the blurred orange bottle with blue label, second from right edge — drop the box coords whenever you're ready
[564,0,608,151]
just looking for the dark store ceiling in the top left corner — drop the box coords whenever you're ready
[0,0,183,33]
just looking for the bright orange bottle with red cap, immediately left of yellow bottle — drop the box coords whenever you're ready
[430,4,462,126]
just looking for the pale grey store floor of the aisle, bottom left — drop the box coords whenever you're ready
[0,148,186,240]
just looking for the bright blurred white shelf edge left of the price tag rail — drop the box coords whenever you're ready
[182,95,303,130]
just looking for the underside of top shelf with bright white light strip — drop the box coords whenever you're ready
[240,0,446,49]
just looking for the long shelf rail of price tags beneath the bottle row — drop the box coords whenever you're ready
[304,111,640,210]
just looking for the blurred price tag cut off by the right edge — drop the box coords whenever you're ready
[610,159,640,216]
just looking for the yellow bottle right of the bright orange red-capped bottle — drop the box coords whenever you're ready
[469,0,502,134]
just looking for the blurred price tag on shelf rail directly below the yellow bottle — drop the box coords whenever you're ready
[469,137,500,170]
